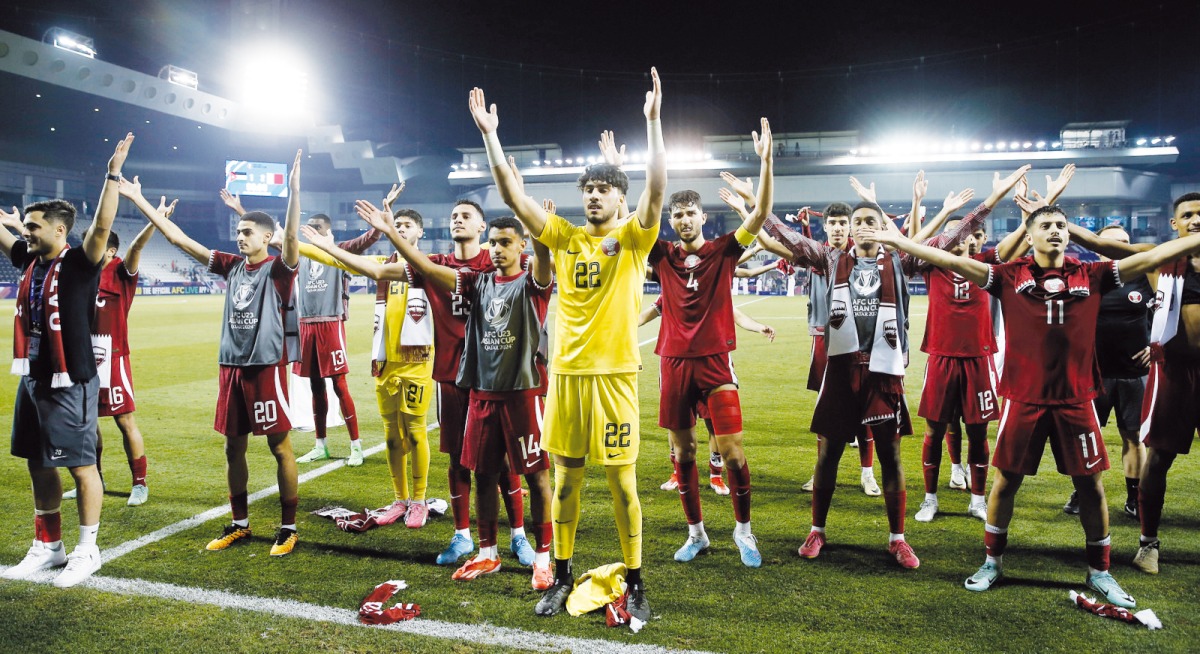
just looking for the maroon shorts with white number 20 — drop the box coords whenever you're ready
[212,362,292,437]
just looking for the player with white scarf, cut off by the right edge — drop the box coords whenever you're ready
[1086,193,1200,575]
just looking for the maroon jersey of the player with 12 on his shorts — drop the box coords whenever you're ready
[920,253,996,356]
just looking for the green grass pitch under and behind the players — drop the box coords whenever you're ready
[0,295,1200,652]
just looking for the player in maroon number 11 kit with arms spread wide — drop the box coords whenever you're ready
[874,190,1200,607]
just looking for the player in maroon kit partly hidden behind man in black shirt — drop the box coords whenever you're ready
[72,176,166,506]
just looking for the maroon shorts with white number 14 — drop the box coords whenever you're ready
[462,394,550,475]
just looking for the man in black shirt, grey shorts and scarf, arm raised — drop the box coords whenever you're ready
[0,133,133,588]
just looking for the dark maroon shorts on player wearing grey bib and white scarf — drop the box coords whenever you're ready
[811,353,912,442]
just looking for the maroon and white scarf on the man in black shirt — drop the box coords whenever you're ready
[12,246,72,389]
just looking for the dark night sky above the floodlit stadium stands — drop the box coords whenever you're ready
[0,0,1200,183]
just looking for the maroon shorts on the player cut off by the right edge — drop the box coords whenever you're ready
[1141,357,1200,454]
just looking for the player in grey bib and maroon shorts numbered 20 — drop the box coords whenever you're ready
[128,151,302,557]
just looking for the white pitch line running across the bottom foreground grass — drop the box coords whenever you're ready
[0,569,707,654]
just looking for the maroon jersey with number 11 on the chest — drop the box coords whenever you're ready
[986,258,1121,404]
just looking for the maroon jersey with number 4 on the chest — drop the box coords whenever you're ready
[649,232,745,358]
